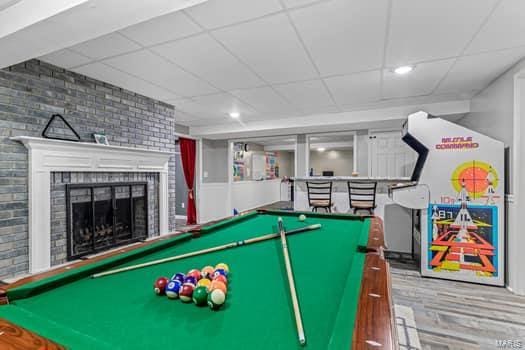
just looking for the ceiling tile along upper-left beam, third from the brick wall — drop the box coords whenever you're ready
[120,11,202,46]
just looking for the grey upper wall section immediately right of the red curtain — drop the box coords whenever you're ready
[202,139,228,183]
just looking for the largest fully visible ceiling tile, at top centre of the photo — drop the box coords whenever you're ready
[213,14,316,83]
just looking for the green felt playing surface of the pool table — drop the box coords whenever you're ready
[0,213,369,349]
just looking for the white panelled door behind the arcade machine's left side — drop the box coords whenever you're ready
[369,131,417,177]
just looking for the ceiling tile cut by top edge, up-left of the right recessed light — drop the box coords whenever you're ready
[290,0,388,75]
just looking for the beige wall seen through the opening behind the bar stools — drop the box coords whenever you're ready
[310,150,354,176]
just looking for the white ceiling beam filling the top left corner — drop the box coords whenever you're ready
[0,0,207,68]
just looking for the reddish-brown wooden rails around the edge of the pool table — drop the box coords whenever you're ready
[0,211,398,350]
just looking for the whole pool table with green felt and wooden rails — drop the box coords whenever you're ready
[0,210,396,350]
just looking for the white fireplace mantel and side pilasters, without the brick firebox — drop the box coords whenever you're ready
[11,136,172,273]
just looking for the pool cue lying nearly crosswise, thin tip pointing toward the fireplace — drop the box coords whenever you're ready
[91,224,321,278]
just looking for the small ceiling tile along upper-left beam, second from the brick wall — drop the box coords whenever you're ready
[70,33,140,59]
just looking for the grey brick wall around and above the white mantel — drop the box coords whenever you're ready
[0,60,175,278]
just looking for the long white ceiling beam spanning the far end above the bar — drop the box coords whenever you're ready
[190,100,470,139]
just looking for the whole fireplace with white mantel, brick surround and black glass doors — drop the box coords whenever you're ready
[12,136,171,273]
